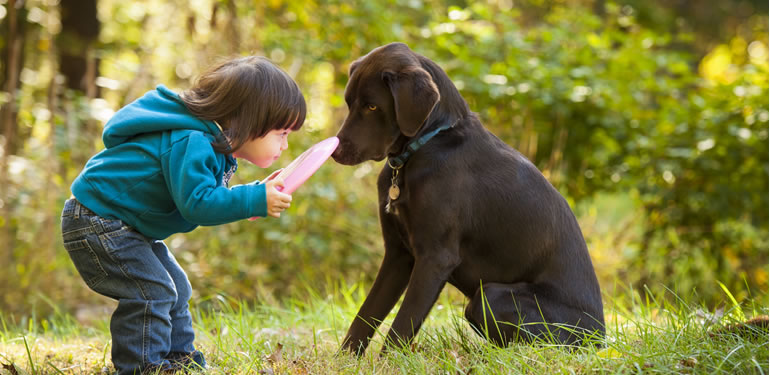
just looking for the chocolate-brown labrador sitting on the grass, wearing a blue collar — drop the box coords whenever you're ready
[332,43,604,355]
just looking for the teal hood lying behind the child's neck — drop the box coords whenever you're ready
[102,85,221,148]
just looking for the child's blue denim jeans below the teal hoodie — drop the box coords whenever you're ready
[62,199,205,375]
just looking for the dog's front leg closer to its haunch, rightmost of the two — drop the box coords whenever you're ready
[383,251,460,352]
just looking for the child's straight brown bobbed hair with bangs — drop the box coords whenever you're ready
[180,56,307,154]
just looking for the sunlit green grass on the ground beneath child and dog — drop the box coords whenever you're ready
[0,285,768,375]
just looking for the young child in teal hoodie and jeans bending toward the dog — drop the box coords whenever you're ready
[62,56,306,375]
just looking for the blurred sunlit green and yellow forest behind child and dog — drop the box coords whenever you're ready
[0,0,769,317]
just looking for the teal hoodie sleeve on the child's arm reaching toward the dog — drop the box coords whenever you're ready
[161,133,267,225]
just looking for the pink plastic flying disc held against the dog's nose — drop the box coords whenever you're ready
[275,137,340,194]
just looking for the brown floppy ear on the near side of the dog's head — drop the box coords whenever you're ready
[382,66,440,137]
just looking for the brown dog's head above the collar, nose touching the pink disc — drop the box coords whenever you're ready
[332,43,440,165]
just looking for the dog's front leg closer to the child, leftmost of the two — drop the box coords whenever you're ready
[342,241,414,355]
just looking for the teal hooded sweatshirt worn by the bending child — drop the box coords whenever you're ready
[71,85,267,239]
